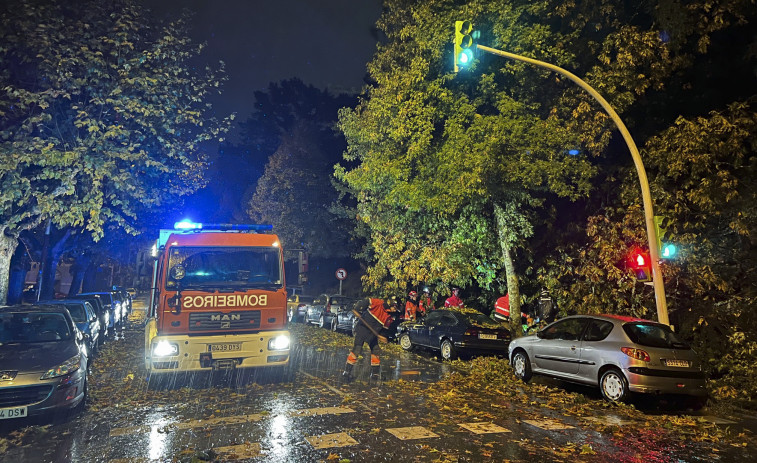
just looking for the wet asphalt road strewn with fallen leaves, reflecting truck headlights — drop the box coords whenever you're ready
[0,302,757,463]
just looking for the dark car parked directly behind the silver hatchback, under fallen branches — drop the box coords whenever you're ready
[397,308,511,360]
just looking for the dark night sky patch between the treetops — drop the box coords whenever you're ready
[142,0,381,136]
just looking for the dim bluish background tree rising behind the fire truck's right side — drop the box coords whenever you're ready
[243,79,352,258]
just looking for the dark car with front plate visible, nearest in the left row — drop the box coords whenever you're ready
[0,305,87,420]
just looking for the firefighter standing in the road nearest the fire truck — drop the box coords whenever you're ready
[342,298,397,382]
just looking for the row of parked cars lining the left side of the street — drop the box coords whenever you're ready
[0,289,132,420]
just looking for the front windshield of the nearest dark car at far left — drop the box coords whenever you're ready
[0,312,72,344]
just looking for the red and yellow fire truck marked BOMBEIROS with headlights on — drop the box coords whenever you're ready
[145,222,290,377]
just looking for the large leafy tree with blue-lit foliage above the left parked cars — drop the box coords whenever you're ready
[0,0,228,300]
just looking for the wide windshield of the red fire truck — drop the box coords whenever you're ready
[166,246,283,289]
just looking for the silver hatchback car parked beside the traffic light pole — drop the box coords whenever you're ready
[509,315,707,403]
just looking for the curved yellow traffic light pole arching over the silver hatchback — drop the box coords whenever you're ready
[475,44,670,325]
